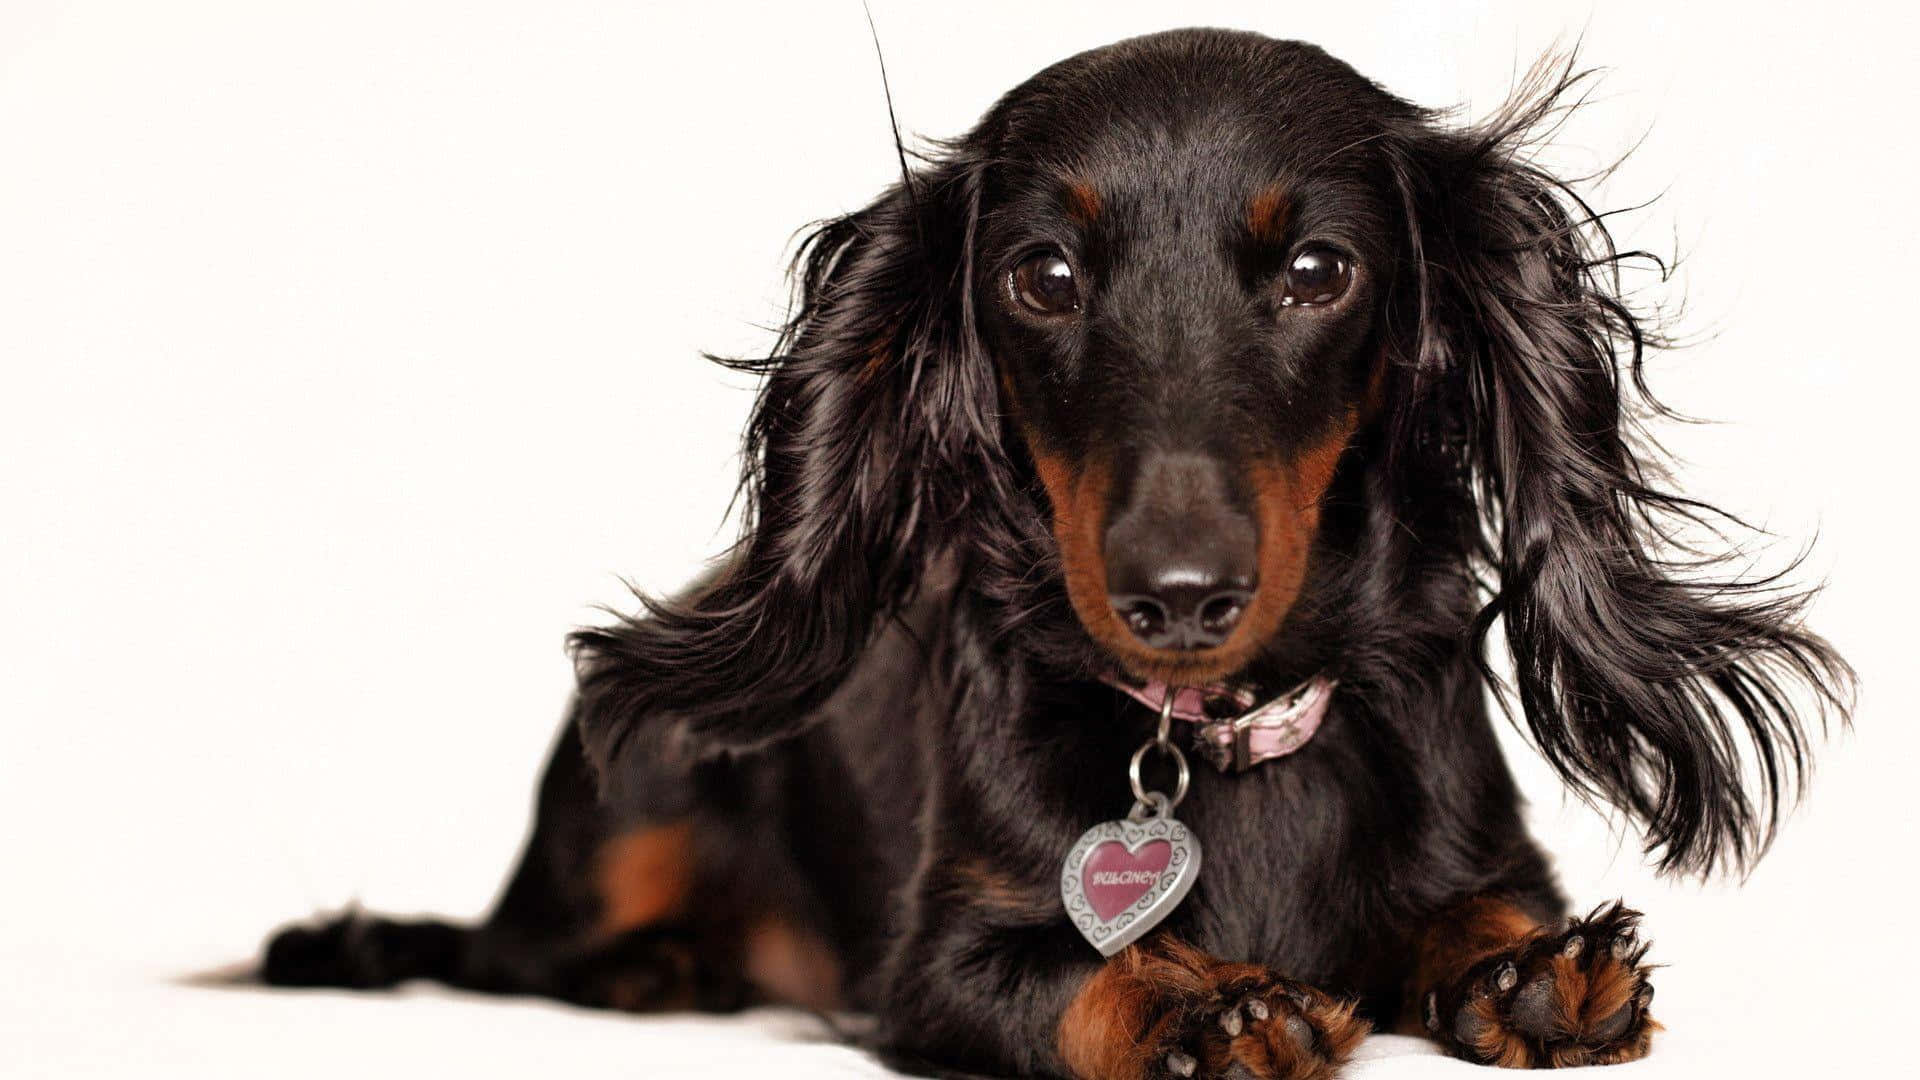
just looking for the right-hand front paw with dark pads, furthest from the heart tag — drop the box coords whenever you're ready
[1421,903,1659,1068]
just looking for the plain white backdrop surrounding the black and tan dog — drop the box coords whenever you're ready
[0,0,1920,1076]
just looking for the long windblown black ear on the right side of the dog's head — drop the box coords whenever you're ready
[1388,67,1851,872]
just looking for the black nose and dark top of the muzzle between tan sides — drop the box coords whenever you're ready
[1106,447,1258,650]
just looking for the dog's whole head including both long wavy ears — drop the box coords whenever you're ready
[576,31,1845,867]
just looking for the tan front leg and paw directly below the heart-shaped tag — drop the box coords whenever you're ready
[1058,940,1367,1080]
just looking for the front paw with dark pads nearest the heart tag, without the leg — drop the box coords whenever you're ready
[1146,969,1367,1080]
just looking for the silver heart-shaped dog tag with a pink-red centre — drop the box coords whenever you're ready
[1060,817,1200,957]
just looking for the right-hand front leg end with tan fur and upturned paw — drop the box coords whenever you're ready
[1402,897,1659,1068]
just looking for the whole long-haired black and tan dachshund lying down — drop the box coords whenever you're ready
[263,31,1849,1080]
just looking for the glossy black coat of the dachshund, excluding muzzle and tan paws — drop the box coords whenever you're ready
[267,31,1849,1072]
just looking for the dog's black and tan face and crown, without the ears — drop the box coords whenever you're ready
[972,33,1411,684]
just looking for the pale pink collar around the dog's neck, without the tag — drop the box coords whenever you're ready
[1104,675,1338,773]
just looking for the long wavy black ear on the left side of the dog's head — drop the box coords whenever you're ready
[572,152,998,786]
